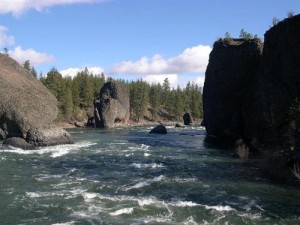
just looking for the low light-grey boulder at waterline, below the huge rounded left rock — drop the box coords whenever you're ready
[26,126,73,146]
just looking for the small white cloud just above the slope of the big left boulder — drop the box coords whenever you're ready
[8,46,55,66]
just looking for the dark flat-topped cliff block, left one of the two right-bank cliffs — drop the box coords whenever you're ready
[203,39,262,139]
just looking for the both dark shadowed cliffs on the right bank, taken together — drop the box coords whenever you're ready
[203,15,300,155]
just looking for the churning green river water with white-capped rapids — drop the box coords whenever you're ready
[0,127,300,225]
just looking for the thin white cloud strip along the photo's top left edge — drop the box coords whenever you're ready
[0,0,107,16]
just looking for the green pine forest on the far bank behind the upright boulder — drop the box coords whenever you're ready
[40,68,203,122]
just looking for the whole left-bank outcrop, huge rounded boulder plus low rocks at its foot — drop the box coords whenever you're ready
[0,54,72,149]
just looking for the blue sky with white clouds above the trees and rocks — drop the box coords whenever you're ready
[0,0,300,87]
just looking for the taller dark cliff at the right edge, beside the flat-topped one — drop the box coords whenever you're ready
[259,15,300,149]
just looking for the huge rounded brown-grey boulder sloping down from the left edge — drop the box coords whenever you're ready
[0,54,58,139]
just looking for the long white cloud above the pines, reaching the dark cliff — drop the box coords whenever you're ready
[112,45,211,75]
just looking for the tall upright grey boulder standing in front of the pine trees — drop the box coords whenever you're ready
[94,81,130,128]
